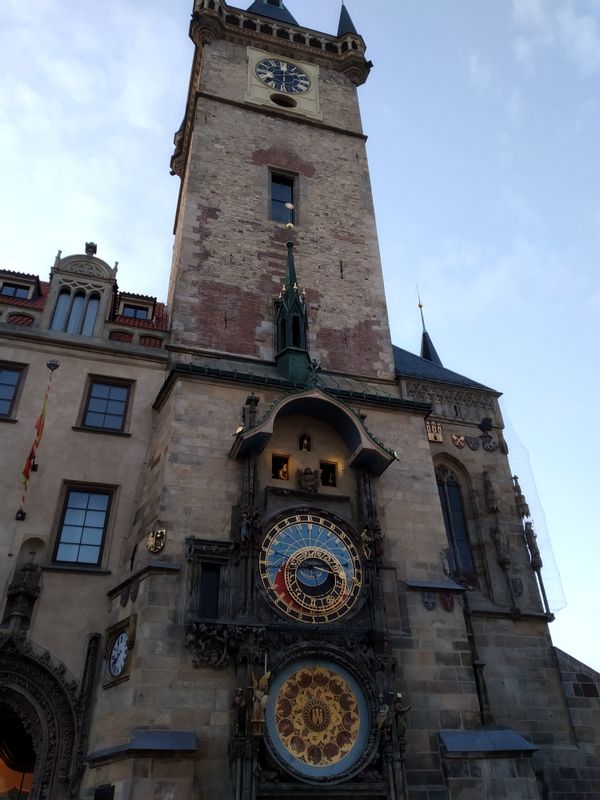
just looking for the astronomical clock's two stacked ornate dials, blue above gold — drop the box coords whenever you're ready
[252,510,376,783]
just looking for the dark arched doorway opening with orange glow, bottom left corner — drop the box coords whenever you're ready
[0,706,35,800]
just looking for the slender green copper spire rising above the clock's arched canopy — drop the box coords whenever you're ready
[275,240,310,384]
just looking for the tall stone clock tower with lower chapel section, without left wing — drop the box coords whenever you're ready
[70,0,600,800]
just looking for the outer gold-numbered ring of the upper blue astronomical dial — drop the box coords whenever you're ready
[259,511,362,625]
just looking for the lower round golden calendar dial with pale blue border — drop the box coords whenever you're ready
[266,661,370,780]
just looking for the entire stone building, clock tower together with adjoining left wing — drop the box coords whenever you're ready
[0,0,600,800]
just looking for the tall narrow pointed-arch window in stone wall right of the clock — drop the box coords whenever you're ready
[435,464,477,589]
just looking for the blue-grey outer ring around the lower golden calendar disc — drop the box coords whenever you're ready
[265,658,372,783]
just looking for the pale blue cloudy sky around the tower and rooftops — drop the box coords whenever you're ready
[0,0,600,670]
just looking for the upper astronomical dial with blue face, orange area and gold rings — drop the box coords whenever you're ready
[259,514,362,623]
